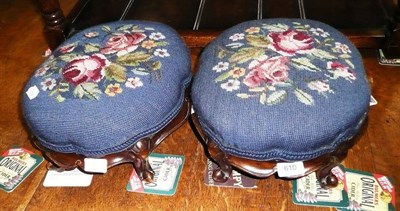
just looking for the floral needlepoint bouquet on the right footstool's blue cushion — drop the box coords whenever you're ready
[212,22,356,105]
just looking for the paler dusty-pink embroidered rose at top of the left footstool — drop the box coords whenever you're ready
[101,33,146,56]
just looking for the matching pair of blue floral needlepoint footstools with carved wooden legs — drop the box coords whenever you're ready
[22,19,370,186]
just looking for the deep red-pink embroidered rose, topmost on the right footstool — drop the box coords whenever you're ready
[267,29,313,56]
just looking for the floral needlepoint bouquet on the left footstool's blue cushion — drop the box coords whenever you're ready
[35,25,171,102]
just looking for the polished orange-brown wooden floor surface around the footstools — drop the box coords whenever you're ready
[0,0,400,210]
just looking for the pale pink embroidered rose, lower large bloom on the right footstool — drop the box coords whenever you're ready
[243,55,289,88]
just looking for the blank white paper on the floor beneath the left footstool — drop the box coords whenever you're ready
[43,168,93,187]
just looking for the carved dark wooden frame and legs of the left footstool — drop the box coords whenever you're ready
[33,98,190,182]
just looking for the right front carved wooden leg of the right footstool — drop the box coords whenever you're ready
[316,156,340,188]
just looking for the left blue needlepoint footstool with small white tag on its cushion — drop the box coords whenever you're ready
[22,21,191,179]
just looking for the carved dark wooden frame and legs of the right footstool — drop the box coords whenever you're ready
[190,114,366,188]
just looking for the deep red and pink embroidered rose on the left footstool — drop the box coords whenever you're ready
[62,54,110,86]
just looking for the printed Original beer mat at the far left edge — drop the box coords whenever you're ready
[0,147,43,192]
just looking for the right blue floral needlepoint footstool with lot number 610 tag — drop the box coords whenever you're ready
[191,19,370,186]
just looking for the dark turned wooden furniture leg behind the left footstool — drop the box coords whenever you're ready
[38,0,67,50]
